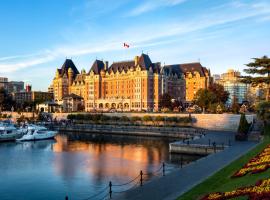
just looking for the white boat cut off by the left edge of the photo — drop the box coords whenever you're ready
[0,123,22,142]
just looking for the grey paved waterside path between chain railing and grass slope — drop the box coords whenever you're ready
[113,132,258,200]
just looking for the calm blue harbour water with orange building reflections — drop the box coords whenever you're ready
[0,133,198,200]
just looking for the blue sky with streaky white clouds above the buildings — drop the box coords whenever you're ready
[0,0,270,91]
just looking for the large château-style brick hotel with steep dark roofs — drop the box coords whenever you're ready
[52,54,210,111]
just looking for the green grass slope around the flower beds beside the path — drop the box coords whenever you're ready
[178,126,270,200]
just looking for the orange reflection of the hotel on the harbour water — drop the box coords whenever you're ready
[53,135,174,182]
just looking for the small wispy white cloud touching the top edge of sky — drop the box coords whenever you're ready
[128,0,186,16]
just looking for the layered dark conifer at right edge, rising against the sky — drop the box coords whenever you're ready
[241,56,270,101]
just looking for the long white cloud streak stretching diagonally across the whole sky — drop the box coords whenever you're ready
[0,0,270,73]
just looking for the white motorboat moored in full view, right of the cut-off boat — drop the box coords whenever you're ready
[17,125,57,141]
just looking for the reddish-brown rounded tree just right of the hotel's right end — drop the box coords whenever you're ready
[209,83,230,104]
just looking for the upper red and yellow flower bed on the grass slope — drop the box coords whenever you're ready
[232,145,270,177]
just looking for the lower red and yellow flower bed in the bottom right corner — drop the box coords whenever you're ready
[201,179,270,200]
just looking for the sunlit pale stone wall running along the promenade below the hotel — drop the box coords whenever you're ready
[3,112,253,131]
